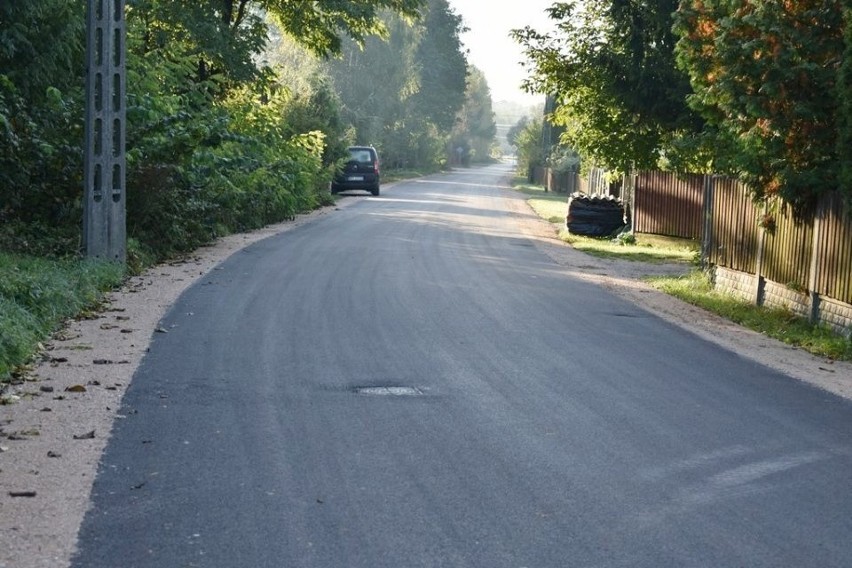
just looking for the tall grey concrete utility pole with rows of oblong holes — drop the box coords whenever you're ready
[83,0,127,262]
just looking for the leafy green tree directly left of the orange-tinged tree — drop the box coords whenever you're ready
[513,0,702,171]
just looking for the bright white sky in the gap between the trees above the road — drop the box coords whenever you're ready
[449,0,555,105]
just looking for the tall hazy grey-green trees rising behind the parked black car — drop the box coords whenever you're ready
[328,0,466,170]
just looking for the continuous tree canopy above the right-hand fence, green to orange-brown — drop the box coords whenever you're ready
[514,0,852,210]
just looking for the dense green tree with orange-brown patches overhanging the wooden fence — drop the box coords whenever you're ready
[675,0,843,210]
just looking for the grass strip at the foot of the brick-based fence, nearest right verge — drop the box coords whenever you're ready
[648,270,852,361]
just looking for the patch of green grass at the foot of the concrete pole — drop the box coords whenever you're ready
[0,252,125,381]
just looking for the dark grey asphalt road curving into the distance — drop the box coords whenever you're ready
[73,163,852,568]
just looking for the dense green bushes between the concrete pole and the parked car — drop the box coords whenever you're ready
[127,79,329,258]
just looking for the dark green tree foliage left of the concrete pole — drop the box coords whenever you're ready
[0,0,85,245]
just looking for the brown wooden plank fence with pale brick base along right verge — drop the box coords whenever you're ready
[625,172,852,332]
